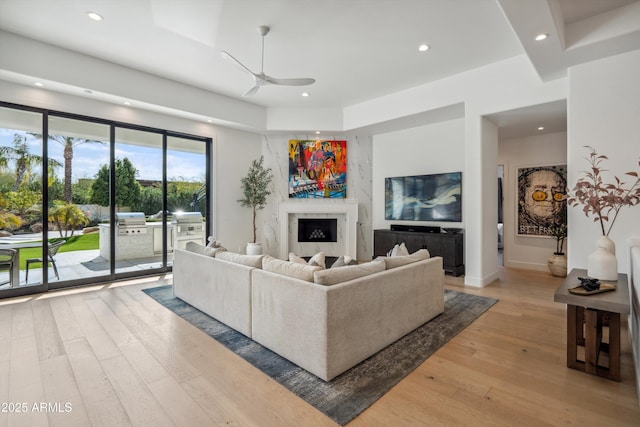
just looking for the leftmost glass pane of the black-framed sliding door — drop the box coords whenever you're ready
[0,107,45,298]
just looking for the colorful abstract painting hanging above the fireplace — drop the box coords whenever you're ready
[289,139,347,199]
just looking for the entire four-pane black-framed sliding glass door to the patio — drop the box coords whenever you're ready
[0,103,211,298]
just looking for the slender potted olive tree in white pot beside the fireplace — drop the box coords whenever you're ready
[238,156,273,255]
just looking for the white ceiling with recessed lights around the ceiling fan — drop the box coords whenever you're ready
[0,0,640,137]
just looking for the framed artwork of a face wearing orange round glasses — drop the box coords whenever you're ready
[516,165,567,236]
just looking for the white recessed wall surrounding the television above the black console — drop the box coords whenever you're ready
[372,119,466,237]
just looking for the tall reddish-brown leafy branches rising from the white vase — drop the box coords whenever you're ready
[567,146,640,236]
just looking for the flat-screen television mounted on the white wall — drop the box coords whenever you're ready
[384,172,462,222]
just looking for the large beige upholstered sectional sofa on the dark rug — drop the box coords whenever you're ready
[173,249,444,381]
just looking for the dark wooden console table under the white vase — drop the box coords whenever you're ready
[553,269,630,381]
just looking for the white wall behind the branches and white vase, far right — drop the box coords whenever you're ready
[567,50,640,273]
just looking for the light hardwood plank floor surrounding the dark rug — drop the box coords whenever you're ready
[0,269,640,427]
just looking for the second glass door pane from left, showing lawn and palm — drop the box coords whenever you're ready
[45,116,111,283]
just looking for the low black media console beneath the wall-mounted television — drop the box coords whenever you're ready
[373,230,464,276]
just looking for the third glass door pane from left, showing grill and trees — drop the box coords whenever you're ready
[111,128,166,274]
